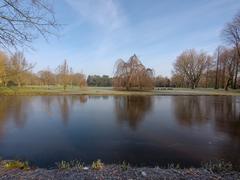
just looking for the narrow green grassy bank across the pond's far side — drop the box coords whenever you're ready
[0,86,240,96]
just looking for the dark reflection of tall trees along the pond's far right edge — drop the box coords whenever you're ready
[214,97,240,166]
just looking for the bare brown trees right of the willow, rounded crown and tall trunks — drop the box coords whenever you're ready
[171,12,240,90]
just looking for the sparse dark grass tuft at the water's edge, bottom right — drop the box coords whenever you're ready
[203,160,233,173]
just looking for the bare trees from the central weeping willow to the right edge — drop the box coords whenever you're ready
[113,12,240,90]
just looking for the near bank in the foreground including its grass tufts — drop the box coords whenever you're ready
[0,160,240,179]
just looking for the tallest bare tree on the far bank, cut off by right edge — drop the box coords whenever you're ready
[222,12,240,89]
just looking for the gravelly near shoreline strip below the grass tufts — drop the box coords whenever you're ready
[0,161,240,179]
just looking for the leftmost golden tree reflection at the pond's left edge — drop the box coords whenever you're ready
[0,96,31,137]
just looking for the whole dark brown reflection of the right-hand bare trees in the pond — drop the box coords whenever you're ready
[173,96,240,167]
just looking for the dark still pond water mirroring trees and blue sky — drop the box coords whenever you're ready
[0,96,240,167]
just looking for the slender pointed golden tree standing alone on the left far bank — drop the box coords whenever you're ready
[57,60,70,90]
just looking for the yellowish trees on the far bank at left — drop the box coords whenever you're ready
[0,52,86,90]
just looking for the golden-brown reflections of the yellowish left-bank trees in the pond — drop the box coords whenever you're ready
[0,96,88,138]
